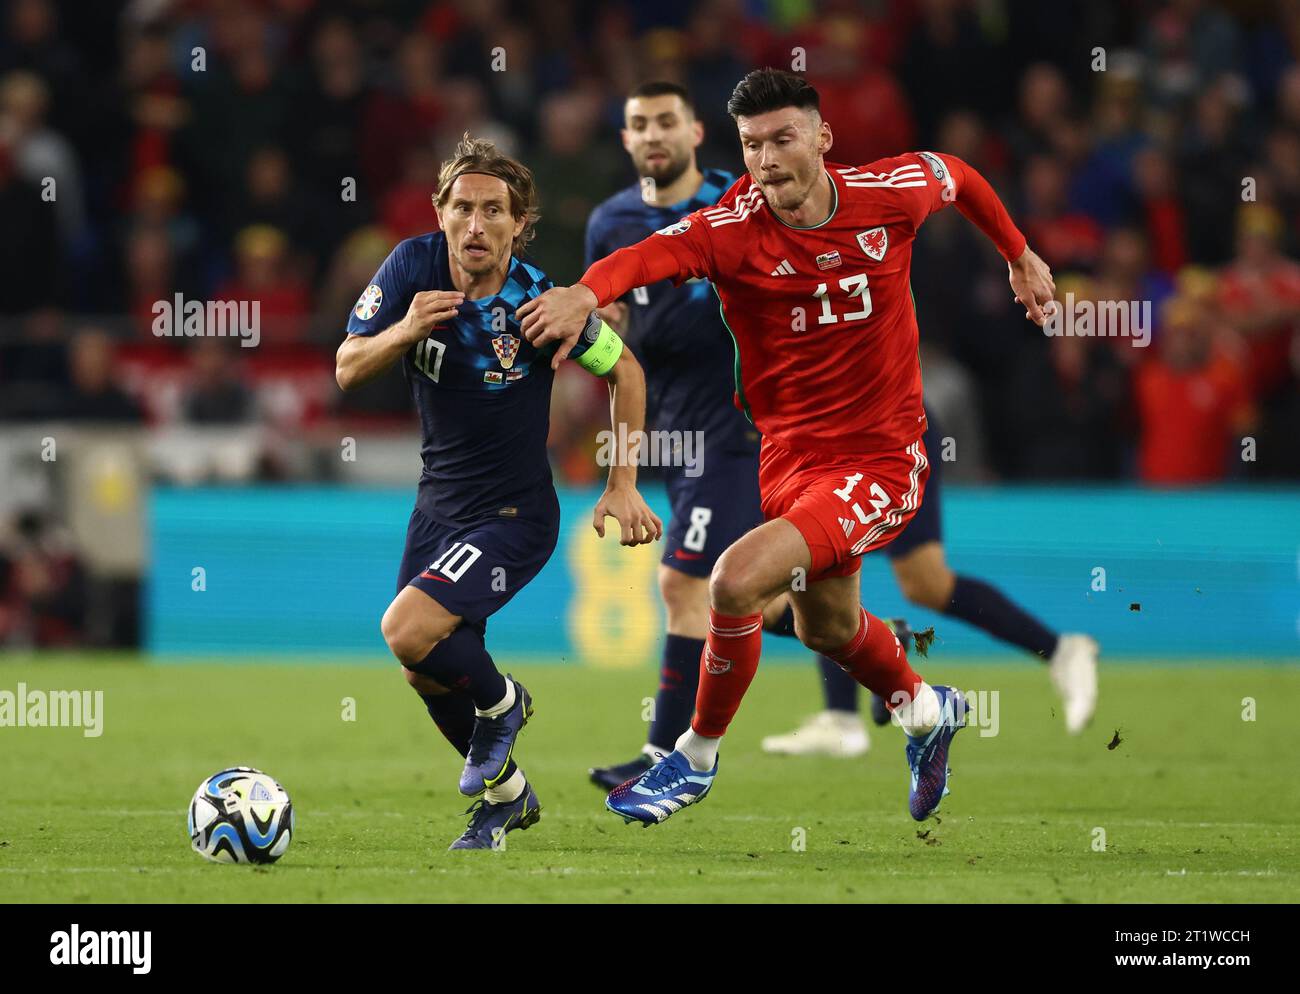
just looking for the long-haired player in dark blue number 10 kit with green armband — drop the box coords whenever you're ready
[337,135,663,848]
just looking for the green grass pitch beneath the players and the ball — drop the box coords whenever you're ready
[0,655,1300,903]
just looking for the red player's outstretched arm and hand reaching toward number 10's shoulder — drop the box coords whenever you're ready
[516,214,712,369]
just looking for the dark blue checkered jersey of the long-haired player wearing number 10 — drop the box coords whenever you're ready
[347,231,588,522]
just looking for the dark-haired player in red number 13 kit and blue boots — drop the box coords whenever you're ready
[519,69,1054,824]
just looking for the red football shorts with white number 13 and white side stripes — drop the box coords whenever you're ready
[758,438,930,581]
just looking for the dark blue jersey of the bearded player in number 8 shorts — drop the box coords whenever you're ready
[586,169,757,448]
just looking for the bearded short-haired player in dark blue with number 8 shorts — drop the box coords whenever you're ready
[586,83,866,790]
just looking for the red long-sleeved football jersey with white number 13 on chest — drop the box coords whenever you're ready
[582,152,1024,453]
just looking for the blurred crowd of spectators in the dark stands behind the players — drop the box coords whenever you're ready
[0,0,1300,491]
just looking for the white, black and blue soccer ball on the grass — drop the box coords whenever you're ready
[187,767,294,863]
